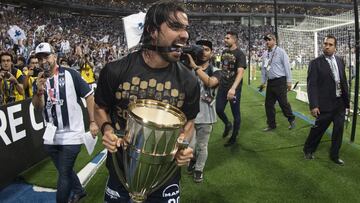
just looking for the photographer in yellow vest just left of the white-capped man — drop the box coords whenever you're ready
[23,55,42,98]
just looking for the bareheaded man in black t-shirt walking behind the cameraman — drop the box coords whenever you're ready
[216,31,246,147]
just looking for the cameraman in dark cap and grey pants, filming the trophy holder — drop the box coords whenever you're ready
[188,40,219,183]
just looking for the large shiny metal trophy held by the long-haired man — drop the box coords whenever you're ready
[112,99,188,203]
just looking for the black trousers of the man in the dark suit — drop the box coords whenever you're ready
[304,98,345,159]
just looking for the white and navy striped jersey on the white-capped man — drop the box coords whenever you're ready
[39,67,93,145]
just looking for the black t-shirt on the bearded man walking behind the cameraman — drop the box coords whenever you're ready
[214,49,246,89]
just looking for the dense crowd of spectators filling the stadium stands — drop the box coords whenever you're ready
[0,0,352,104]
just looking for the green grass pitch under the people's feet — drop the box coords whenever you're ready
[23,71,360,203]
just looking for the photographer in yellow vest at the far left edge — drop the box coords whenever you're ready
[0,52,24,104]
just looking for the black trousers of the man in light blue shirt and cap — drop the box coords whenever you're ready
[265,77,295,128]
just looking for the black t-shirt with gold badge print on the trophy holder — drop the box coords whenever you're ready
[95,51,200,179]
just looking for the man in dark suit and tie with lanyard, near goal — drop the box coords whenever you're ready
[303,35,350,165]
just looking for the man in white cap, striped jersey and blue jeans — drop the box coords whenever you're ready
[32,43,98,203]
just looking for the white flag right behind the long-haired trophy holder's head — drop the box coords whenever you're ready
[123,12,146,49]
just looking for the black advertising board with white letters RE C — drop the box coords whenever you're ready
[0,99,89,190]
